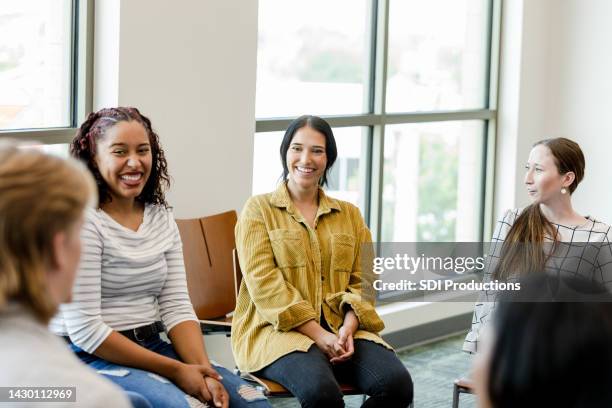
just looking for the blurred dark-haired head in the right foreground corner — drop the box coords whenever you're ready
[473,273,612,408]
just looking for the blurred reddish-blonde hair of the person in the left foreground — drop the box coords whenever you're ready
[0,143,95,322]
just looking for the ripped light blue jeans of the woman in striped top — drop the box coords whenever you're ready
[71,337,270,408]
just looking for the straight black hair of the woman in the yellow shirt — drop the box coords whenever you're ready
[280,115,338,186]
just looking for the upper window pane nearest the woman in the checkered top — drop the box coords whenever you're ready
[386,0,490,112]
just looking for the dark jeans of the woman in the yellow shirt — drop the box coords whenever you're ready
[254,340,413,408]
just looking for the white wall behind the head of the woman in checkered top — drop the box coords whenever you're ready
[495,0,612,223]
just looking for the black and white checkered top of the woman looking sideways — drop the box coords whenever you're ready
[463,209,612,353]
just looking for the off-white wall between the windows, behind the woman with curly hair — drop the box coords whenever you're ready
[94,0,257,218]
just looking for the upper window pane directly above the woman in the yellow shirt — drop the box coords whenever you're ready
[255,0,370,118]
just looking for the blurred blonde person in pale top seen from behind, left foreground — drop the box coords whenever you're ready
[0,141,130,408]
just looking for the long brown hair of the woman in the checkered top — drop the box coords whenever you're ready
[493,137,585,280]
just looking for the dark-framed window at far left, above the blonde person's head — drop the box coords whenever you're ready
[0,0,93,146]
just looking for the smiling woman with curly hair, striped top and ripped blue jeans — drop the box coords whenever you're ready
[53,107,269,407]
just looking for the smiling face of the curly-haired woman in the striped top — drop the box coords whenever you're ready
[94,121,153,200]
